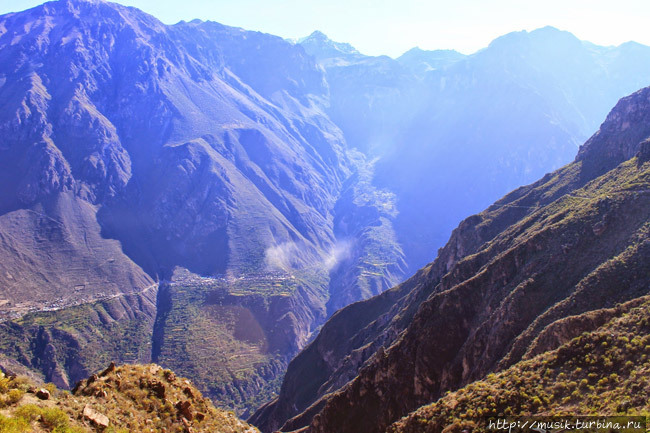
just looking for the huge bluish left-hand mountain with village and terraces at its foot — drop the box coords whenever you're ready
[0,0,403,410]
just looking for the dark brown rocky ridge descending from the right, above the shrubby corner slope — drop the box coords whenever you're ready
[251,88,650,432]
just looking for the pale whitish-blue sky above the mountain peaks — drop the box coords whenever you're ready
[0,0,650,57]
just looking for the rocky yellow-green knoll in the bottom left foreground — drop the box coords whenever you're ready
[0,364,258,433]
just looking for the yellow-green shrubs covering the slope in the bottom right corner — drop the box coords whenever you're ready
[388,297,650,433]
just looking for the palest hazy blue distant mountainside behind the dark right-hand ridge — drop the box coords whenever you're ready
[303,27,650,272]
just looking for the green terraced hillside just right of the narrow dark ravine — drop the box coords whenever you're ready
[156,274,301,413]
